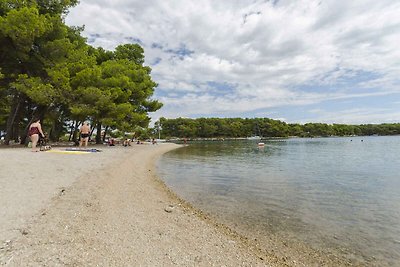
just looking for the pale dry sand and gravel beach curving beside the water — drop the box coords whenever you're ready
[0,144,274,266]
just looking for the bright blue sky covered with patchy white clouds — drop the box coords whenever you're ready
[65,0,400,124]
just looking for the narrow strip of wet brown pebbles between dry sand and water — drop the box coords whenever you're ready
[156,147,354,266]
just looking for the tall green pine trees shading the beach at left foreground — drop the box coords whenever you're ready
[0,0,162,144]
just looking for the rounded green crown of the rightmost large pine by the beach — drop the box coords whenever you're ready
[71,55,161,131]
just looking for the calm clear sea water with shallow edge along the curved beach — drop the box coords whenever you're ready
[158,136,400,266]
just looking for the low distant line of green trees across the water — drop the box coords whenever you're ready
[154,118,400,138]
